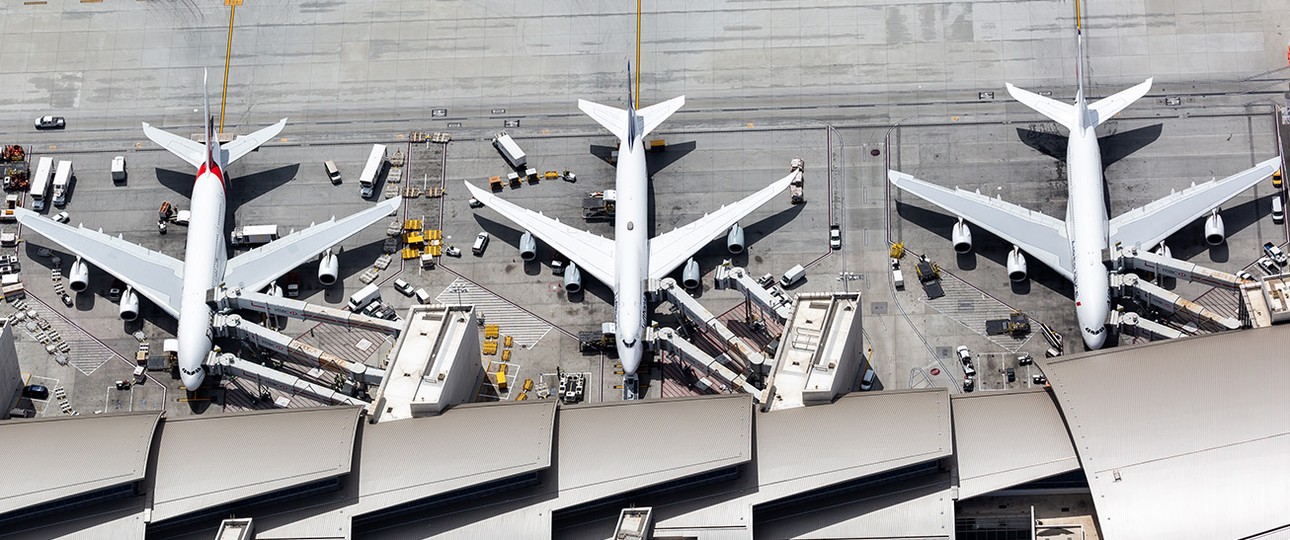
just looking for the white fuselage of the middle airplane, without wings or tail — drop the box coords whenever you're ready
[614,137,649,374]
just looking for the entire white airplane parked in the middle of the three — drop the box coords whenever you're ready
[466,75,793,379]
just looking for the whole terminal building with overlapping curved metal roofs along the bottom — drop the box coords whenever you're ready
[0,326,1290,540]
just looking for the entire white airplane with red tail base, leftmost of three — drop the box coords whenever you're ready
[15,72,401,391]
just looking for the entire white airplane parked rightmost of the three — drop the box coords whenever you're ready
[888,31,1281,349]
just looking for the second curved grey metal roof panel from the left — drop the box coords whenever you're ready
[151,407,362,522]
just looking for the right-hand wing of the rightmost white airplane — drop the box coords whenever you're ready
[1111,157,1281,249]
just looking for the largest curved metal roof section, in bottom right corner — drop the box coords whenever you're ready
[1044,326,1290,539]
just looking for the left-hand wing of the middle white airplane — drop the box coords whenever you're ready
[466,182,618,290]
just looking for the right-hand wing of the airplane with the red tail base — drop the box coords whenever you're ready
[224,197,402,290]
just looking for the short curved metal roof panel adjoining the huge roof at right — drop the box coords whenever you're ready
[949,389,1080,500]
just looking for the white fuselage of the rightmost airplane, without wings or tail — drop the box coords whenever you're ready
[1066,119,1111,349]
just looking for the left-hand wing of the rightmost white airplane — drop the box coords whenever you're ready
[888,170,1075,280]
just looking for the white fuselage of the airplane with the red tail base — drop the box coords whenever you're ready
[178,165,228,391]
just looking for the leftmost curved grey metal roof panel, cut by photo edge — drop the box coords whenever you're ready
[0,412,161,514]
